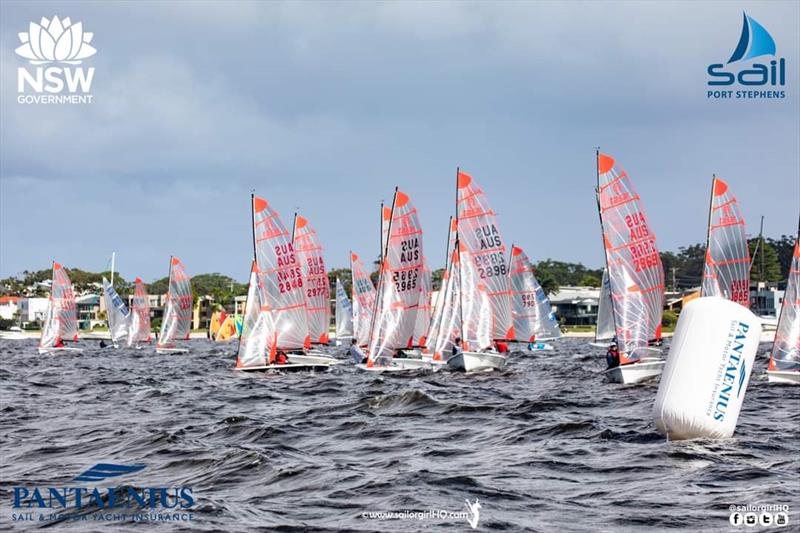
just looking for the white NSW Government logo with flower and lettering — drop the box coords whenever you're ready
[15,16,97,104]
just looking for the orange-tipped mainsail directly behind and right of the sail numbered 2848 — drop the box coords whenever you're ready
[292,215,331,344]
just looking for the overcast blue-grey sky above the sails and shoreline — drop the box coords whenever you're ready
[0,1,800,280]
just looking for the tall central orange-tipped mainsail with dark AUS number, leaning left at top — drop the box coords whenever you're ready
[457,171,515,339]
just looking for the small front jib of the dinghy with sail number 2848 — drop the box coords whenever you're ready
[236,261,277,368]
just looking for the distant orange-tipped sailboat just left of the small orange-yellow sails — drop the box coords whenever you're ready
[156,257,192,354]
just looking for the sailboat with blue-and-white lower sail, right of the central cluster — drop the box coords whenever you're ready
[510,245,561,351]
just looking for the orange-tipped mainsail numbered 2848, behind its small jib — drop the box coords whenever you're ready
[253,196,311,350]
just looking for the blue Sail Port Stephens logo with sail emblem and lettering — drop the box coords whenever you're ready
[706,12,786,100]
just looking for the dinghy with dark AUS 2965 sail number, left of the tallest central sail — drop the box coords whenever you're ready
[356,188,431,372]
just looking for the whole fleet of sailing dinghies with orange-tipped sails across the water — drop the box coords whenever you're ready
[29,156,800,383]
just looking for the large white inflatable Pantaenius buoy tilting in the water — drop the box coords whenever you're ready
[653,297,761,440]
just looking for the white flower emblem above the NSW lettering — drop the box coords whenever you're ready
[15,16,97,65]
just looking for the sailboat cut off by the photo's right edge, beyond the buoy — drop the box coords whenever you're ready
[767,231,800,385]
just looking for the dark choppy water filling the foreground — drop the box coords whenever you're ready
[0,339,800,531]
